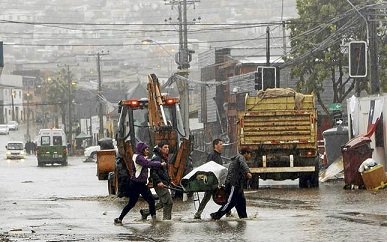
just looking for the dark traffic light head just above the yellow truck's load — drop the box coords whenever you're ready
[255,66,278,91]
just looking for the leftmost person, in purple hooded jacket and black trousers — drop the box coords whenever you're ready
[114,142,167,225]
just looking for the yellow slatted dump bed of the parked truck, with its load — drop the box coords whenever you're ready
[239,88,317,148]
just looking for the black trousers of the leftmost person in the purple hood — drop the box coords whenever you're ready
[119,181,156,220]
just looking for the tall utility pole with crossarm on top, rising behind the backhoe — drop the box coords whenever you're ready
[165,0,200,138]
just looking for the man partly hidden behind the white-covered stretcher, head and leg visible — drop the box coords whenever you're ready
[194,139,223,219]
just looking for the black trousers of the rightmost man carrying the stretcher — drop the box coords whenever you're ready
[212,186,247,219]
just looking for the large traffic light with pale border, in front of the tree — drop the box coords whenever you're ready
[349,41,367,77]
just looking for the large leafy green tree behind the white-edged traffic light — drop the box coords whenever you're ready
[287,0,376,114]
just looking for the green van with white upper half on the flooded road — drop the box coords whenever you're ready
[36,129,68,166]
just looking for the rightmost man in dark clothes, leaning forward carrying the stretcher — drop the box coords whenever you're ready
[210,148,252,220]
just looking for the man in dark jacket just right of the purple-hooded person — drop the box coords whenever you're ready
[140,141,173,220]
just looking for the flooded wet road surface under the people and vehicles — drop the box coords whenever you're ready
[0,130,387,241]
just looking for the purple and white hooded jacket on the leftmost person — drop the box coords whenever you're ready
[130,142,161,183]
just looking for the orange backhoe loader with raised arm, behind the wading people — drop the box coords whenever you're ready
[108,74,192,197]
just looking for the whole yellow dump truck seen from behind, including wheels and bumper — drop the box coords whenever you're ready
[237,88,319,188]
